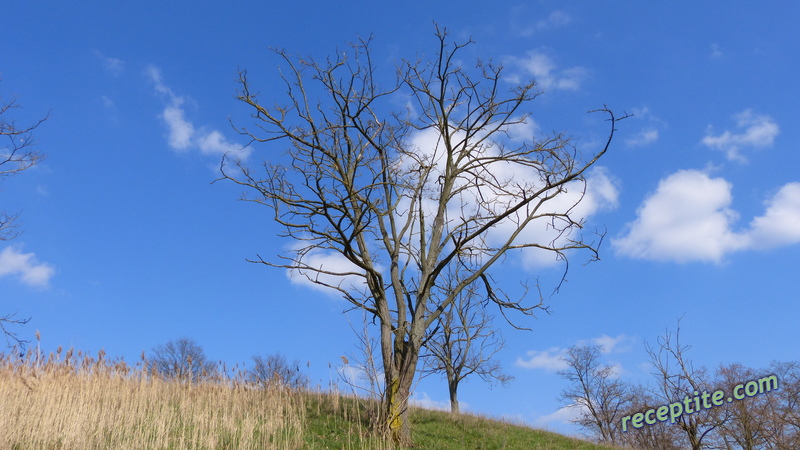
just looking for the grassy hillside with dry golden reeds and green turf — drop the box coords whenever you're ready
[0,351,603,449]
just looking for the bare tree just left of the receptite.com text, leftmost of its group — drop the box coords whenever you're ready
[558,345,631,443]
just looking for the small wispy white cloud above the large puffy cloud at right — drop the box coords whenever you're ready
[701,109,780,162]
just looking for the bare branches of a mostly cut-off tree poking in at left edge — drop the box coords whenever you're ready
[0,81,47,346]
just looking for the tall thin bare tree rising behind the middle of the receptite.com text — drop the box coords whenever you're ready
[645,320,727,450]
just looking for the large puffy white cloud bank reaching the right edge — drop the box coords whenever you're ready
[612,170,800,263]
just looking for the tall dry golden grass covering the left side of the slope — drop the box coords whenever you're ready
[0,351,305,449]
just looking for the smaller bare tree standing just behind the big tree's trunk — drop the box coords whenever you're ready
[421,271,513,413]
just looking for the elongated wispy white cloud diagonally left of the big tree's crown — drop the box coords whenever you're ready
[145,66,252,160]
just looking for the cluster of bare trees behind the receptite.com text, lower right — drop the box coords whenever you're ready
[559,321,800,450]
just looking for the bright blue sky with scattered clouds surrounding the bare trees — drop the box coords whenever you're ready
[0,1,800,432]
